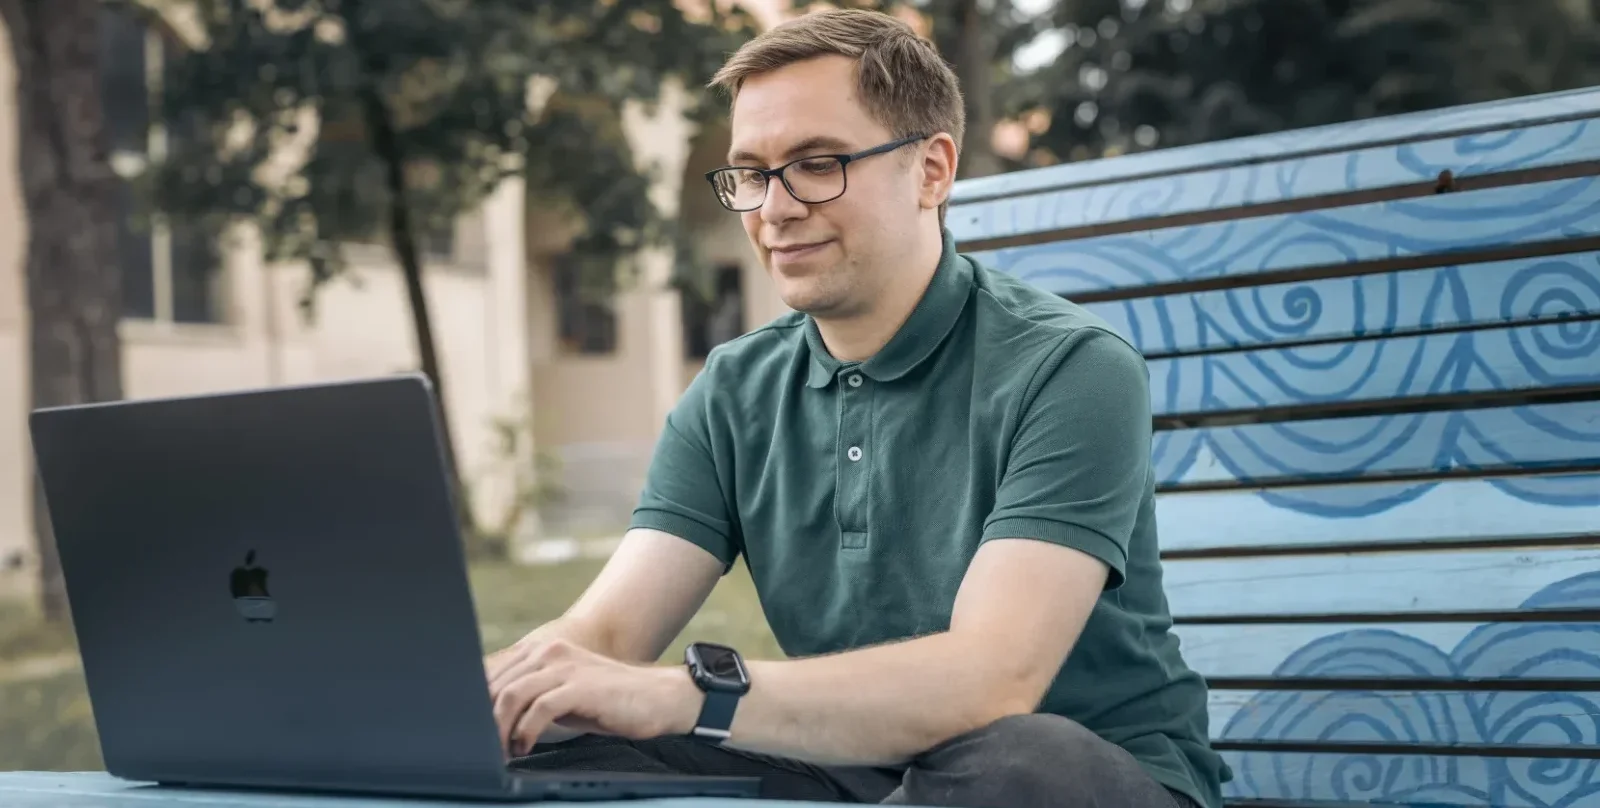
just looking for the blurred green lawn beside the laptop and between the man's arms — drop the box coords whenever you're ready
[0,560,781,771]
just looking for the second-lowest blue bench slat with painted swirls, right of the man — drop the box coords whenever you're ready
[1206,688,1600,752]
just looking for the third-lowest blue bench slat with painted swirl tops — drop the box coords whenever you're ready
[1173,620,1600,684]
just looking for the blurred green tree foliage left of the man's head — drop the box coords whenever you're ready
[142,0,750,305]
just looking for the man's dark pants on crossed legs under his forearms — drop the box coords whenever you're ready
[514,714,1198,808]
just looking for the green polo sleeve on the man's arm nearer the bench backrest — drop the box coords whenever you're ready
[982,328,1152,589]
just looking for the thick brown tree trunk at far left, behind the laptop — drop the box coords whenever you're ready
[0,0,122,621]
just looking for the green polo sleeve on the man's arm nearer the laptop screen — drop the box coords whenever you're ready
[629,362,741,570]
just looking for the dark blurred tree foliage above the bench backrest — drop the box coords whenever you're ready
[1005,0,1600,162]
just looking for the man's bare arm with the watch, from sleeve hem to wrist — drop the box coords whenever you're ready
[694,539,1106,765]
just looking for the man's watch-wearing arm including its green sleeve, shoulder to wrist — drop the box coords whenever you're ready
[659,331,1150,765]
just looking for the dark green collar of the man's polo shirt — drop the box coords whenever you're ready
[805,229,973,387]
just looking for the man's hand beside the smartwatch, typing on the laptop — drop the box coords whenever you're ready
[486,637,704,755]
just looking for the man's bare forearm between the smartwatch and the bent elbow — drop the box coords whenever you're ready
[684,634,1037,765]
